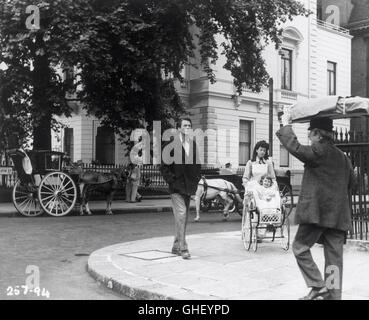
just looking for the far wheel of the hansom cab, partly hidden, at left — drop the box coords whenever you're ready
[12,180,43,217]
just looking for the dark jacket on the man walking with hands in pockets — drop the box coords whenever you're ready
[160,136,201,195]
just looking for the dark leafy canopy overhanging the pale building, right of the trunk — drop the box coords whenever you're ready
[75,0,308,141]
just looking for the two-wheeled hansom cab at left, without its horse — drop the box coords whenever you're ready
[9,149,77,217]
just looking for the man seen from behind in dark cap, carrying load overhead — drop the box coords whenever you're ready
[276,118,353,300]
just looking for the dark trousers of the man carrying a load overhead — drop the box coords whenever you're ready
[292,224,345,300]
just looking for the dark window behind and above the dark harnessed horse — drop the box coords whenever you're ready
[95,127,115,164]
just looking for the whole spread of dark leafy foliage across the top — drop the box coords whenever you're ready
[0,0,308,150]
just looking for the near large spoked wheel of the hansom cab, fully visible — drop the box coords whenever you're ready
[38,172,77,217]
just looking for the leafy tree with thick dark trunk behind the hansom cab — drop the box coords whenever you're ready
[0,0,91,149]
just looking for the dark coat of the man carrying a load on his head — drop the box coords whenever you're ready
[276,125,354,231]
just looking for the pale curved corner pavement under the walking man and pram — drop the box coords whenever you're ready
[88,226,369,300]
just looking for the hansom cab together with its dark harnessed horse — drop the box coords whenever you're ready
[8,149,126,217]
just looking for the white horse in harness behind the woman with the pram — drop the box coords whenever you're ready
[195,177,243,221]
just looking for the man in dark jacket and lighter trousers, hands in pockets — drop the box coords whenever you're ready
[160,118,201,259]
